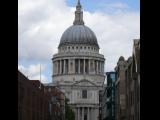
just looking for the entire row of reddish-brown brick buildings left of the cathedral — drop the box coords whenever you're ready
[18,71,64,120]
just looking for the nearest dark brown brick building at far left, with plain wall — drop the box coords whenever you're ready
[18,71,51,120]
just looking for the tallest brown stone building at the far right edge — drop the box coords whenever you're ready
[126,39,140,120]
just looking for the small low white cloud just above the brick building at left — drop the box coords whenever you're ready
[18,64,49,83]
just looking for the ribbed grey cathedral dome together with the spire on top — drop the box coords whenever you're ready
[59,0,99,48]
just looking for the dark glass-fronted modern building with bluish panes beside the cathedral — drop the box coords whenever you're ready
[102,72,116,120]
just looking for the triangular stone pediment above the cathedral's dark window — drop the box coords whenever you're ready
[72,79,97,87]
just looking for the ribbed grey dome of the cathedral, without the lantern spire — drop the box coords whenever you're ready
[59,25,99,47]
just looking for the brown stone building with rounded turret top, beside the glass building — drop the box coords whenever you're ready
[115,56,127,120]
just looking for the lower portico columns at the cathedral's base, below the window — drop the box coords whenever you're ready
[75,107,95,120]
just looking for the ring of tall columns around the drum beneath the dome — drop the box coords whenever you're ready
[53,59,104,75]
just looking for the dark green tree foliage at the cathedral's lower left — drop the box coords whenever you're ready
[65,98,75,120]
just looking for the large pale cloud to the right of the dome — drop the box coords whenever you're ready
[84,12,140,71]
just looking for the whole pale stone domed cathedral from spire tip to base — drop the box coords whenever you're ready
[52,0,105,120]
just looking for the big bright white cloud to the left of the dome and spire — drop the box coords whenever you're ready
[18,0,72,60]
